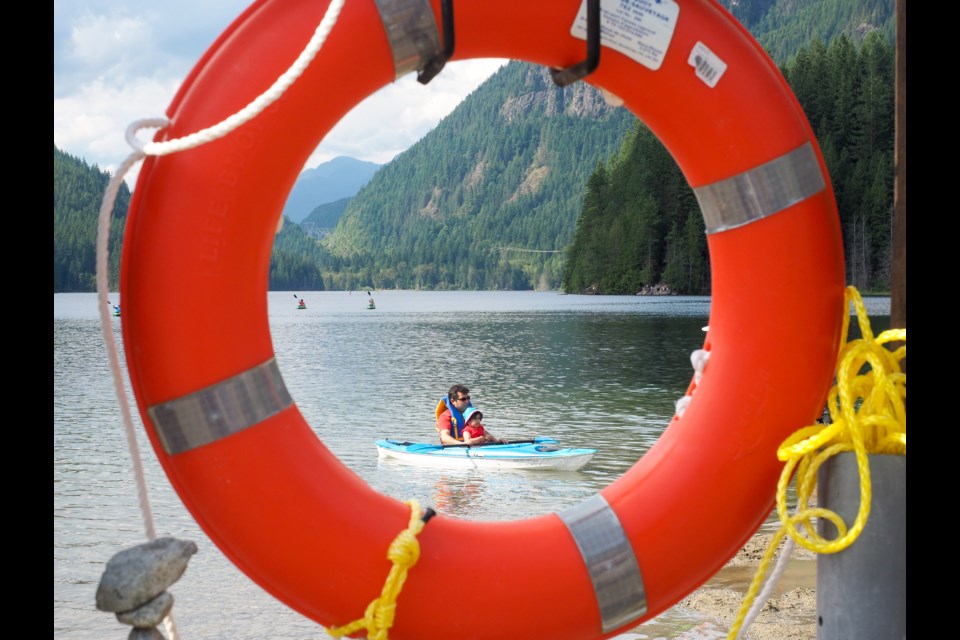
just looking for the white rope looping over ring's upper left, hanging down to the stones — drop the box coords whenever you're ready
[96,0,345,640]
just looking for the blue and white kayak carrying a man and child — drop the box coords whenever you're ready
[376,438,597,471]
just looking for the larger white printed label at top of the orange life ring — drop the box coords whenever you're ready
[570,0,680,71]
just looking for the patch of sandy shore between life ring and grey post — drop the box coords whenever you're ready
[676,534,817,640]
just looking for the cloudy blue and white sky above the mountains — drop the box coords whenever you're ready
[53,0,505,188]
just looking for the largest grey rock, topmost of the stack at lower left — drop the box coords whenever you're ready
[97,537,197,613]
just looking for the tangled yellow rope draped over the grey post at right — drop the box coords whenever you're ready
[727,287,907,640]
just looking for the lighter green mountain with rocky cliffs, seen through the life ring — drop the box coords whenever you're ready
[321,62,636,289]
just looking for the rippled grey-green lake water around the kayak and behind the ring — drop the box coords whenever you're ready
[53,291,890,640]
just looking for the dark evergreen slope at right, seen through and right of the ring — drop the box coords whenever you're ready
[563,31,894,294]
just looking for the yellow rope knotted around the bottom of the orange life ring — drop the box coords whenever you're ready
[327,500,426,640]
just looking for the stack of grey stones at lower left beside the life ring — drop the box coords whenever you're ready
[97,538,197,640]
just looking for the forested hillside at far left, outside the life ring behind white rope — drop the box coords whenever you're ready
[53,145,130,293]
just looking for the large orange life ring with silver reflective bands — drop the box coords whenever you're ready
[120,0,846,640]
